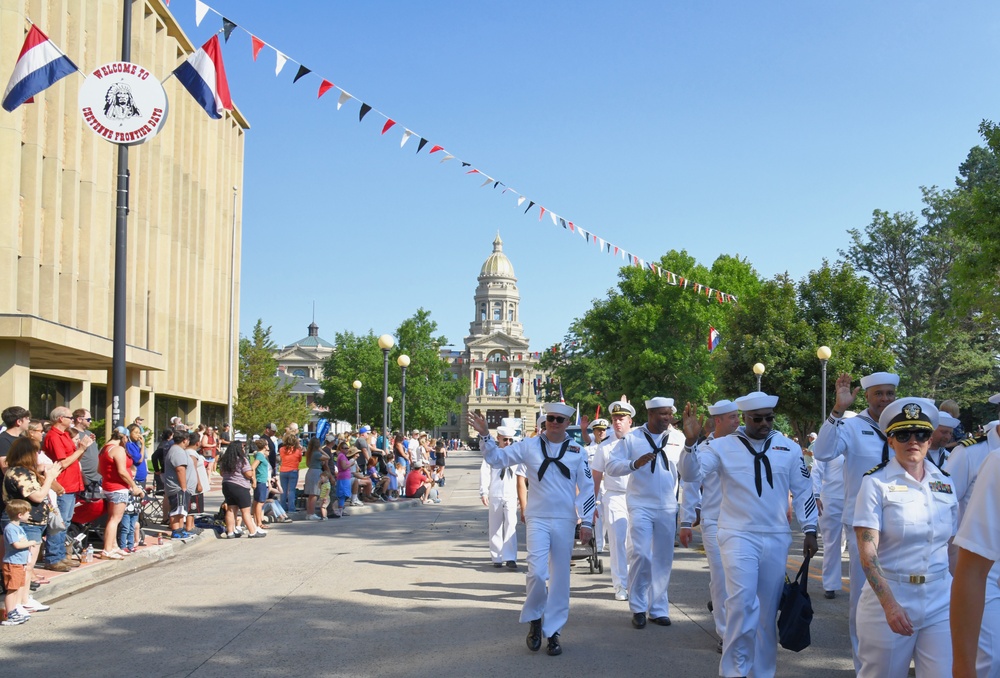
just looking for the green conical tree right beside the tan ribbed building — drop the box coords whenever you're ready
[233,319,310,434]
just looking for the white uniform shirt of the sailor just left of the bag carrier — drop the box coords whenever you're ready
[606,424,684,512]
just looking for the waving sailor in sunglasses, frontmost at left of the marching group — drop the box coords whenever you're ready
[469,403,595,656]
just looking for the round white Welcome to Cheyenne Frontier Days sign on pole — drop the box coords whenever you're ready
[80,61,167,146]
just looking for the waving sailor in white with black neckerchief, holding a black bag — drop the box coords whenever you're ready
[680,391,817,678]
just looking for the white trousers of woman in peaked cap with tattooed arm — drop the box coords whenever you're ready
[857,576,951,678]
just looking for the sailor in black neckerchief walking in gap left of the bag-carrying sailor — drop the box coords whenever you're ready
[605,397,684,629]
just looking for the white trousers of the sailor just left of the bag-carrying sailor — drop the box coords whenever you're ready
[628,506,677,617]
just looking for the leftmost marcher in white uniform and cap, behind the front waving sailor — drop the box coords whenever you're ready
[479,426,524,570]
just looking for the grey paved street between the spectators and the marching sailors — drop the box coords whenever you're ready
[0,452,853,678]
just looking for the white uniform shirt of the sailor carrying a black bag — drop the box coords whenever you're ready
[679,426,816,534]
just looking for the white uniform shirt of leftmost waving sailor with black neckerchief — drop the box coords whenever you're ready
[480,433,595,527]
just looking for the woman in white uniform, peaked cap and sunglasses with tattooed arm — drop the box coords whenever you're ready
[854,398,958,678]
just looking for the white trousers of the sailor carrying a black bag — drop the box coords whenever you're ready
[719,528,792,678]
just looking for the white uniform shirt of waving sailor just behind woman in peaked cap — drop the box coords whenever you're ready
[813,410,893,525]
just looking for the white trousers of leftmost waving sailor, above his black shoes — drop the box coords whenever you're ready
[520,517,576,638]
